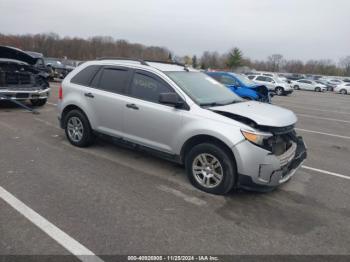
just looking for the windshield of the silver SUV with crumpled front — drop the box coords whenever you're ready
[165,71,243,106]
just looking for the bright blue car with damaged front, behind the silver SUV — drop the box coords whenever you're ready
[206,71,271,103]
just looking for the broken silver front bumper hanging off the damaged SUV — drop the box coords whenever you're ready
[232,137,307,190]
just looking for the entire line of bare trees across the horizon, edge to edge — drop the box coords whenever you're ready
[0,33,350,76]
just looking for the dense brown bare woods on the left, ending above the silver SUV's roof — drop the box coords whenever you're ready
[0,33,170,60]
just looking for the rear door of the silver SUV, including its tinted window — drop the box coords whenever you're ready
[84,66,131,137]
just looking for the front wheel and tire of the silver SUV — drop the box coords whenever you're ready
[185,143,237,195]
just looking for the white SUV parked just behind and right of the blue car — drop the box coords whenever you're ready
[249,75,293,96]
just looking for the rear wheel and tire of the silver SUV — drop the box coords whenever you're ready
[64,109,95,147]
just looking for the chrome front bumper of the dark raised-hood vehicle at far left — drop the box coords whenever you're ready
[0,88,50,100]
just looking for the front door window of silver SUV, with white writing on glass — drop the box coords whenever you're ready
[130,73,174,103]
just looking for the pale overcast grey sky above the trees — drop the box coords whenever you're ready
[0,0,350,61]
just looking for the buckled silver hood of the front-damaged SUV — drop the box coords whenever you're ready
[210,101,298,127]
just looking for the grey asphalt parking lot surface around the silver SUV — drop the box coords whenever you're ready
[0,84,350,255]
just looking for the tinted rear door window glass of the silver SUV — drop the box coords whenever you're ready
[98,68,129,94]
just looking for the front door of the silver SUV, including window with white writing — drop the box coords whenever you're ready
[123,70,183,153]
